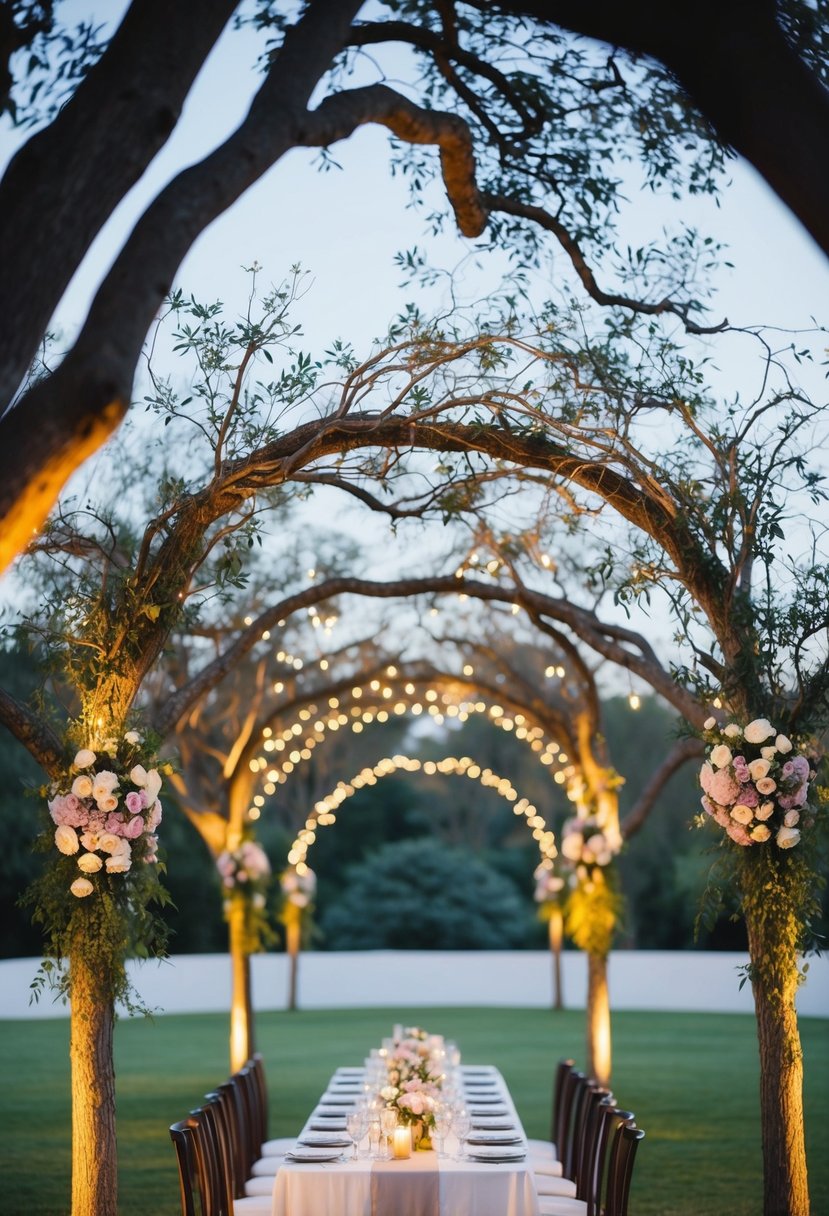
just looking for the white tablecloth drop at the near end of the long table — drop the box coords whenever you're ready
[273,1070,538,1216]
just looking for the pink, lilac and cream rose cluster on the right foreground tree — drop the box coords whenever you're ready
[699,717,816,849]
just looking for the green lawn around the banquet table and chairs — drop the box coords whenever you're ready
[0,1009,829,1216]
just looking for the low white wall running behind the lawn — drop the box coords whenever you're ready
[0,951,829,1018]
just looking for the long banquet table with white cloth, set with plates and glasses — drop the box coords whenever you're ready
[273,1068,538,1216]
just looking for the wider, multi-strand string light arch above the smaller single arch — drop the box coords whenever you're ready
[241,666,575,820]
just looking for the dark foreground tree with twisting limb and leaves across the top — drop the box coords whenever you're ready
[0,0,829,568]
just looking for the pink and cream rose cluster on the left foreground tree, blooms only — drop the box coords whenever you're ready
[47,731,162,899]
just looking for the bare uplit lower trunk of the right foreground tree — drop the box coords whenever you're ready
[745,894,810,1216]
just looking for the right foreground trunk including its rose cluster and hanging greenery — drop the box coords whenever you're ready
[699,717,820,1216]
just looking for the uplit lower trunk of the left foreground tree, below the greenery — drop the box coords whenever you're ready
[69,950,118,1216]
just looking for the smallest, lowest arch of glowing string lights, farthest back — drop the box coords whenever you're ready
[280,754,558,874]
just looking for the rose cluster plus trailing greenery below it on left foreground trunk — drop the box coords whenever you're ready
[21,730,170,1012]
